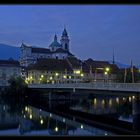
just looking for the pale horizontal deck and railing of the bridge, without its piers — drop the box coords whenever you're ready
[28,83,140,93]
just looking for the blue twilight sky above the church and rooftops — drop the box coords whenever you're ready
[0,5,140,65]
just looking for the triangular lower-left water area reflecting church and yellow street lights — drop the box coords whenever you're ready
[0,96,113,136]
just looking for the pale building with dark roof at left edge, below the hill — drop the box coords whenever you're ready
[0,59,20,86]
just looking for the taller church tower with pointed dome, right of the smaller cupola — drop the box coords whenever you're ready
[60,28,69,51]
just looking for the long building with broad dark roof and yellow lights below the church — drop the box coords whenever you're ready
[26,58,83,84]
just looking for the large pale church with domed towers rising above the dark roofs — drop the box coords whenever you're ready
[20,28,74,67]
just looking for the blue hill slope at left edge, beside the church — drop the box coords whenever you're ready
[0,43,20,60]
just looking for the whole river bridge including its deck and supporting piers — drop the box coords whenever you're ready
[28,83,140,132]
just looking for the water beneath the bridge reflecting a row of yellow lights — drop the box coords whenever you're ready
[71,94,135,122]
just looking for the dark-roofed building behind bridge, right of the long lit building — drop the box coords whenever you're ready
[82,58,119,82]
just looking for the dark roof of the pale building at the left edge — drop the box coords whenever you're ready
[0,60,20,66]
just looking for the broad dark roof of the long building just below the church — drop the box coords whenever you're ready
[28,58,72,71]
